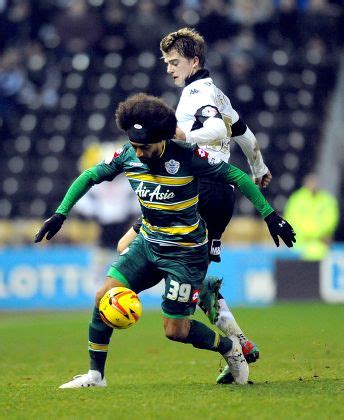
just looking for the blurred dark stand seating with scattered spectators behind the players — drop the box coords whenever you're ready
[0,0,344,249]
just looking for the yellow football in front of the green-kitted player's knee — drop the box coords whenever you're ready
[99,287,142,329]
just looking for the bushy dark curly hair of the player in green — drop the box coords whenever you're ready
[115,93,177,143]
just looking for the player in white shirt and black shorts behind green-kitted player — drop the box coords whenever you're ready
[160,28,272,383]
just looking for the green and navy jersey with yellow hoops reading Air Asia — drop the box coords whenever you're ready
[57,140,273,247]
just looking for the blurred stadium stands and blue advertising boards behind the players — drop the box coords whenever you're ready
[0,0,344,309]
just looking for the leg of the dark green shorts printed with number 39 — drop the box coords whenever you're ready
[159,245,208,318]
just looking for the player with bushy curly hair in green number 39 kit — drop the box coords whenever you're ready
[35,93,295,388]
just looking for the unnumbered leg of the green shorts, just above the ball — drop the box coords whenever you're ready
[108,234,162,293]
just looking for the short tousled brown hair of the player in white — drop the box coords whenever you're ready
[160,28,205,67]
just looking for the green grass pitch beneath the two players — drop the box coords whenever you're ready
[0,303,344,420]
